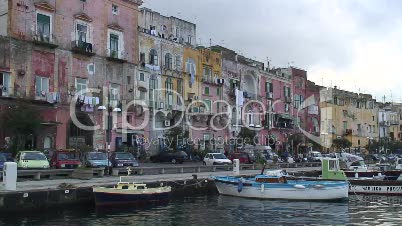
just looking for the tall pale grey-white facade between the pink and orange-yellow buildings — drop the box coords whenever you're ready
[138,8,196,152]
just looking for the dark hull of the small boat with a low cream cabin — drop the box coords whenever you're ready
[94,188,170,206]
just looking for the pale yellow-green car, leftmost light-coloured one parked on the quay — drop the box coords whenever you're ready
[15,151,50,169]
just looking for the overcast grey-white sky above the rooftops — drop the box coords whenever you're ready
[143,0,402,102]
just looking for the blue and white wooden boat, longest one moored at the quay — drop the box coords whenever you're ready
[213,171,349,201]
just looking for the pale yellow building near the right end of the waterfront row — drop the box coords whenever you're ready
[320,88,379,148]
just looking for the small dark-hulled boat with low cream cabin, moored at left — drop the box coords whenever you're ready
[93,180,172,206]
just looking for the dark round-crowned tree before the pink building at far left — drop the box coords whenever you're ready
[0,102,42,154]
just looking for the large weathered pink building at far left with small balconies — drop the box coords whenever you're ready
[0,0,142,150]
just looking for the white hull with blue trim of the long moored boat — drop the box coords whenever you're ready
[215,179,348,201]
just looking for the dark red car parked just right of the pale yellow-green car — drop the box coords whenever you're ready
[50,151,82,169]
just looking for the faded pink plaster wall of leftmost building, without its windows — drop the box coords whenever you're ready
[0,0,142,150]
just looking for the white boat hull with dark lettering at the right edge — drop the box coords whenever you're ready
[349,180,402,196]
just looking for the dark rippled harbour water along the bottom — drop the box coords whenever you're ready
[0,195,402,226]
